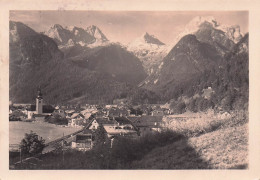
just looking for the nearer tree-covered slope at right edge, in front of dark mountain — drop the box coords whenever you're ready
[160,34,249,113]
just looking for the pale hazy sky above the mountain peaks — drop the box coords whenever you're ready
[9,10,248,44]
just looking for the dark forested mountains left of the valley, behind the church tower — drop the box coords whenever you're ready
[9,21,155,104]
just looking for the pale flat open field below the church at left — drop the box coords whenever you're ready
[9,121,79,144]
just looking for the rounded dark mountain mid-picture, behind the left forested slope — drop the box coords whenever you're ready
[62,44,147,84]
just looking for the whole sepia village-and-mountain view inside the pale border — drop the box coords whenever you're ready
[9,11,249,169]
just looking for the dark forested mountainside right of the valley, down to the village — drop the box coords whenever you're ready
[142,29,249,113]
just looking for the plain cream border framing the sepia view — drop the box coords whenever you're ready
[0,0,260,180]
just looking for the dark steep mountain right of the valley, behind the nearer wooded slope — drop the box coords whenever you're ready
[145,35,221,93]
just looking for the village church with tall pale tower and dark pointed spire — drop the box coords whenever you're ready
[27,89,54,121]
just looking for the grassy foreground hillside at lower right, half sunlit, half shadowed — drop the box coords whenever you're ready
[132,124,248,169]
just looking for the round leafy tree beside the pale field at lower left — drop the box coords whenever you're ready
[20,131,45,155]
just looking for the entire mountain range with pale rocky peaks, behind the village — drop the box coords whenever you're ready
[9,17,248,112]
